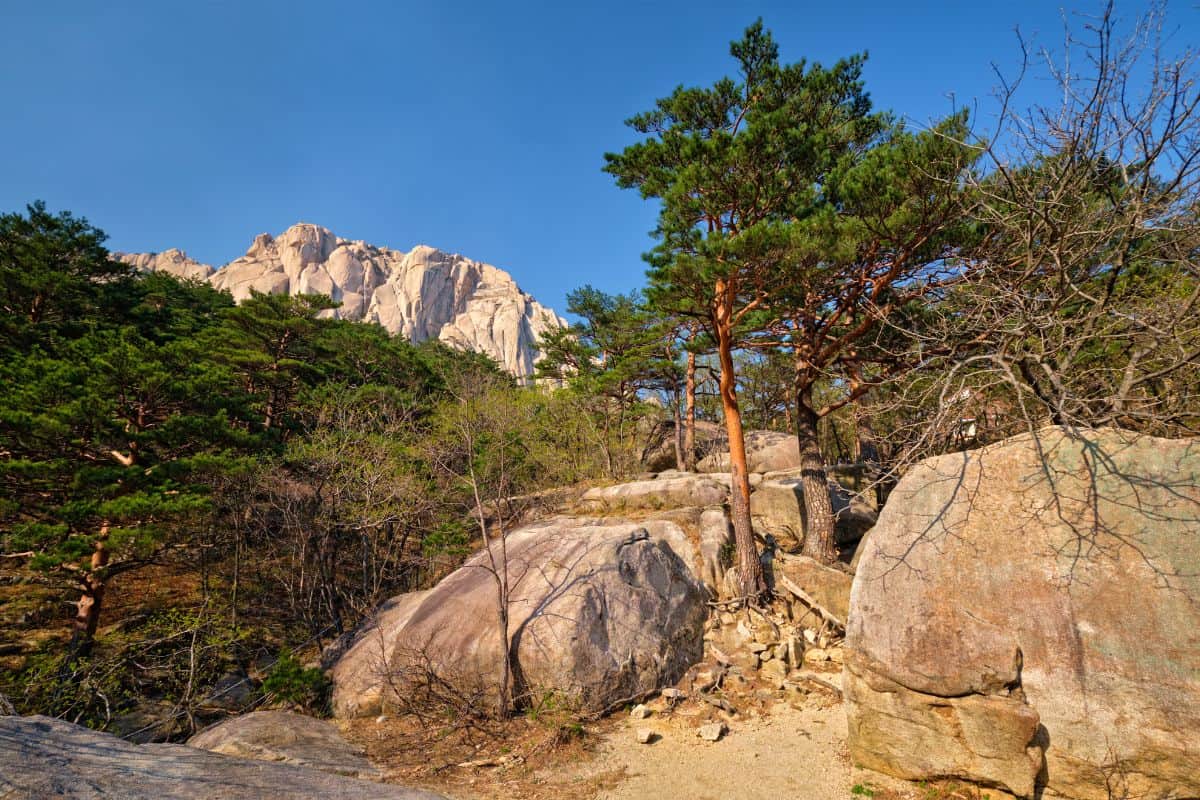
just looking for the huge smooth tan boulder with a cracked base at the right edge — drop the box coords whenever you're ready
[845,428,1200,800]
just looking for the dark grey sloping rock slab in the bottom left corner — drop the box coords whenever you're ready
[0,716,440,800]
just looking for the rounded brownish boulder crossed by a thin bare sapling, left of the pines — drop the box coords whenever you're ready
[330,518,708,716]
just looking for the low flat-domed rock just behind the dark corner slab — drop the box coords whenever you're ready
[187,711,379,780]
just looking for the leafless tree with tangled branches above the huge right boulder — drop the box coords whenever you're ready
[873,4,1200,465]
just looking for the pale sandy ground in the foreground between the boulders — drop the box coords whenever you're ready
[355,692,920,800]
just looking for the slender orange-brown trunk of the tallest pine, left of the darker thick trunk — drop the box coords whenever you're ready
[713,291,767,597]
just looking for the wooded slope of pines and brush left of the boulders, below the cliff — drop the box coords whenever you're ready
[0,204,629,727]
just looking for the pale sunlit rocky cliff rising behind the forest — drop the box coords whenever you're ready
[114,223,566,377]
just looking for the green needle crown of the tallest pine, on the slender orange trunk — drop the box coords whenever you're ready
[605,20,889,326]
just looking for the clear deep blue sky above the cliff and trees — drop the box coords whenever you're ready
[0,0,1200,311]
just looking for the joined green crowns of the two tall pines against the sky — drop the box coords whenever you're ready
[605,20,978,431]
